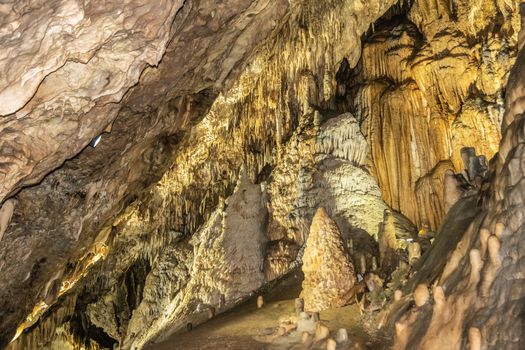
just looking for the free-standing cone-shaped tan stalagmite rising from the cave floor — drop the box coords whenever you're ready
[301,208,356,311]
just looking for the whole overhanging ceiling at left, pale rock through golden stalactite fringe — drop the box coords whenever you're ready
[0,0,400,345]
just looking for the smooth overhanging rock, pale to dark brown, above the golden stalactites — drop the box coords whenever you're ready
[0,0,289,345]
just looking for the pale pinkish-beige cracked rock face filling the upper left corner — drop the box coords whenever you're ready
[0,0,183,201]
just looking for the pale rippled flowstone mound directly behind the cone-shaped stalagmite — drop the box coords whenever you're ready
[267,113,415,282]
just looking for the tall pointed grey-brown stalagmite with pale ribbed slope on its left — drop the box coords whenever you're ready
[145,173,266,344]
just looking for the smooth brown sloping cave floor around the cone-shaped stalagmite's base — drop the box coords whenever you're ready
[146,275,378,350]
